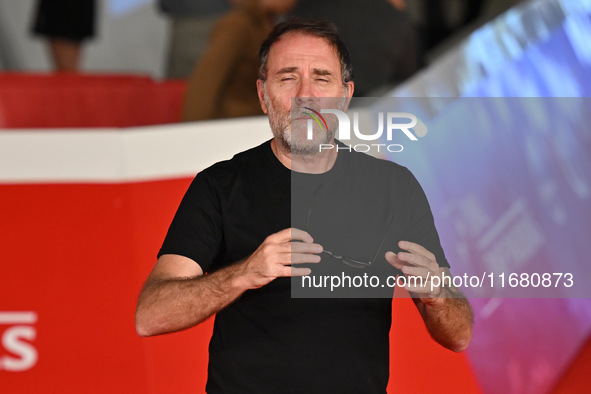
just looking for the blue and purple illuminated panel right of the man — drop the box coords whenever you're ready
[373,0,591,393]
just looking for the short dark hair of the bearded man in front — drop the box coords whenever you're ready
[259,18,353,85]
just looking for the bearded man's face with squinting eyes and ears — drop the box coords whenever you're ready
[257,32,353,155]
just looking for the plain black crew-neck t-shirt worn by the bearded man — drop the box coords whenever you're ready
[159,141,448,393]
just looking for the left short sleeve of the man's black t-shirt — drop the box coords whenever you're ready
[158,170,222,272]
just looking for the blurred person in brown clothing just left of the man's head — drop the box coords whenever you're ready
[183,0,296,121]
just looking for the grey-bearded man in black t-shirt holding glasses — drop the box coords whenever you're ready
[136,20,472,393]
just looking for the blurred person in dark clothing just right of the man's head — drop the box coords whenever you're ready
[292,0,421,96]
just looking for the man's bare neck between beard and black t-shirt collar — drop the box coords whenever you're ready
[271,138,337,174]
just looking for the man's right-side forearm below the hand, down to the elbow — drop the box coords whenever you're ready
[415,289,474,352]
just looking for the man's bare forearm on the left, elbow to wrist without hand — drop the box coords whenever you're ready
[135,264,246,336]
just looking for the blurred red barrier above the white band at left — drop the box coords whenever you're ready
[0,73,185,128]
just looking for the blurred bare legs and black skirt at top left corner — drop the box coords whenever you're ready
[33,0,96,72]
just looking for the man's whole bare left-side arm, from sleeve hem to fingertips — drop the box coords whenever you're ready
[136,228,322,336]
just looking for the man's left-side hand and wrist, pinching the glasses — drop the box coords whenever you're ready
[237,228,323,289]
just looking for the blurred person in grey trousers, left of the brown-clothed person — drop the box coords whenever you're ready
[158,0,234,79]
